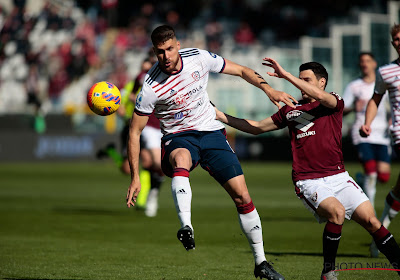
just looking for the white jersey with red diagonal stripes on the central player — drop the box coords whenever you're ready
[135,49,225,135]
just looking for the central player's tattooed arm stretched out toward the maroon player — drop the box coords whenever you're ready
[222,59,297,108]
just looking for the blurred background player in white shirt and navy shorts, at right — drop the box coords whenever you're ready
[343,52,390,206]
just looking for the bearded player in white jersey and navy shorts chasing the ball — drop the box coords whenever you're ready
[127,25,297,279]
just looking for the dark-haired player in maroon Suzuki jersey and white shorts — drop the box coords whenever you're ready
[216,58,400,280]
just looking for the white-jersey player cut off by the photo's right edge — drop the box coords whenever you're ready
[360,24,400,249]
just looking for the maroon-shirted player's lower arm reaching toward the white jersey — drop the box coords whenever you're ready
[214,107,278,135]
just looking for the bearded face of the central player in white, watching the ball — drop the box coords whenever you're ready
[154,38,181,73]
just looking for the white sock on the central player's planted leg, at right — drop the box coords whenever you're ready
[239,209,266,265]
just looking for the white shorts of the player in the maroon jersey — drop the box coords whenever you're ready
[296,171,368,223]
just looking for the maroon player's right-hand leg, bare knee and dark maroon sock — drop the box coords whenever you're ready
[352,201,400,274]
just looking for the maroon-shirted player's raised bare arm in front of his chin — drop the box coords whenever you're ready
[263,57,337,108]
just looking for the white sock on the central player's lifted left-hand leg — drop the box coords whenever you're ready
[171,176,193,229]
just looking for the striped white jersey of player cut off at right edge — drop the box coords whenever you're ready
[374,59,400,144]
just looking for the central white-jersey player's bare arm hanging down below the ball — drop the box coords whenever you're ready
[126,113,149,207]
